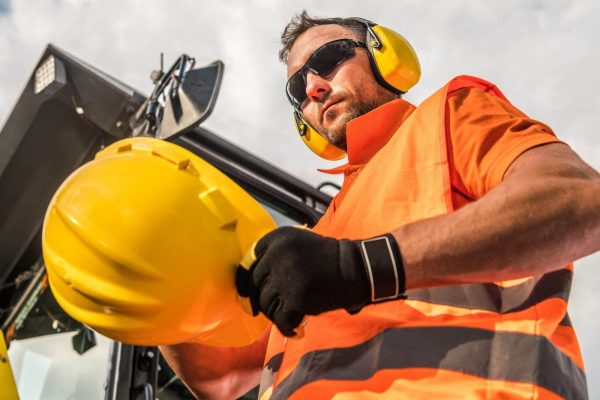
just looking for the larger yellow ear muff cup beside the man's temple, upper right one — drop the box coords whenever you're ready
[367,25,421,92]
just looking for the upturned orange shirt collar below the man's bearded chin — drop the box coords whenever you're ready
[319,99,415,174]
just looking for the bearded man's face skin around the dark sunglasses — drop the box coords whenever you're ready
[287,25,398,150]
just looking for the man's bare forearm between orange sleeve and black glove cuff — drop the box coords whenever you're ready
[393,143,600,289]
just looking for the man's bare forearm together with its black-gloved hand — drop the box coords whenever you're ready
[238,143,600,336]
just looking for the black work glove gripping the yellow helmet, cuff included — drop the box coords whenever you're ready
[236,227,405,336]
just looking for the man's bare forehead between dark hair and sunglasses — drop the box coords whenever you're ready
[287,24,360,78]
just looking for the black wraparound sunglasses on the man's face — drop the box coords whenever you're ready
[285,39,367,110]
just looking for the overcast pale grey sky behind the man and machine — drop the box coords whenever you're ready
[0,0,600,398]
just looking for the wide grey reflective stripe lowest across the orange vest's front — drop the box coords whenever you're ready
[272,327,587,400]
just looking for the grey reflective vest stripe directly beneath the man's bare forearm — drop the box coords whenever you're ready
[406,269,573,314]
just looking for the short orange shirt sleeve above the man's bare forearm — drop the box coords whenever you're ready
[445,88,560,199]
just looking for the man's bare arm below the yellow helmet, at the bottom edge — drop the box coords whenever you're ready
[160,329,270,399]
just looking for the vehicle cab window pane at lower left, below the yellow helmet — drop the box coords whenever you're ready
[8,289,113,400]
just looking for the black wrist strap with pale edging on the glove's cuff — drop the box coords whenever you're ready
[359,234,406,303]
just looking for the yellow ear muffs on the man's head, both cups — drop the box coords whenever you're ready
[294,18,421,161]
